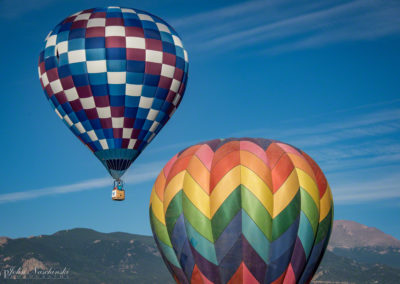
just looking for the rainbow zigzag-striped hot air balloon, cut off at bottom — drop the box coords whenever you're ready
[150,138,333,284]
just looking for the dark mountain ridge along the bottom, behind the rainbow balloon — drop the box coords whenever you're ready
[0,221,400,284]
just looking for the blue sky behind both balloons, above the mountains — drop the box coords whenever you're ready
[0,0,400,238]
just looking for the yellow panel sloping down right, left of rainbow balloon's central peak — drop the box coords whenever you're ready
[183,172,211,219]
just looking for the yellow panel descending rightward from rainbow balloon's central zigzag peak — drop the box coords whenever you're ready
[241,166,273,215]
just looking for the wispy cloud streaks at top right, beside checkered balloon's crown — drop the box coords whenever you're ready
[177,0,400,53]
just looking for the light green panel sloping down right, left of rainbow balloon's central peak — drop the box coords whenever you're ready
[182,193,214,242]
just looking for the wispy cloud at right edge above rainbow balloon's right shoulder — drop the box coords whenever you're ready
[288,108,400,172]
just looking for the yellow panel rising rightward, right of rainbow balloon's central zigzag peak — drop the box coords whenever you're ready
[271,169,300,218]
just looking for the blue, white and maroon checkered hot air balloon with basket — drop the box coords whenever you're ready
[39,7,188,200]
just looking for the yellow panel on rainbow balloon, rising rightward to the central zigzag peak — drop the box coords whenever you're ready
[210,165,240,218]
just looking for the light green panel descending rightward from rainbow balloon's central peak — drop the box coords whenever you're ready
[242,185,272,241]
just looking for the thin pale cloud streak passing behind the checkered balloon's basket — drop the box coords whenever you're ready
[0,162,165,204]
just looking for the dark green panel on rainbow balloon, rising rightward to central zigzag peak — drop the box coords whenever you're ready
[211,186,241,241]
